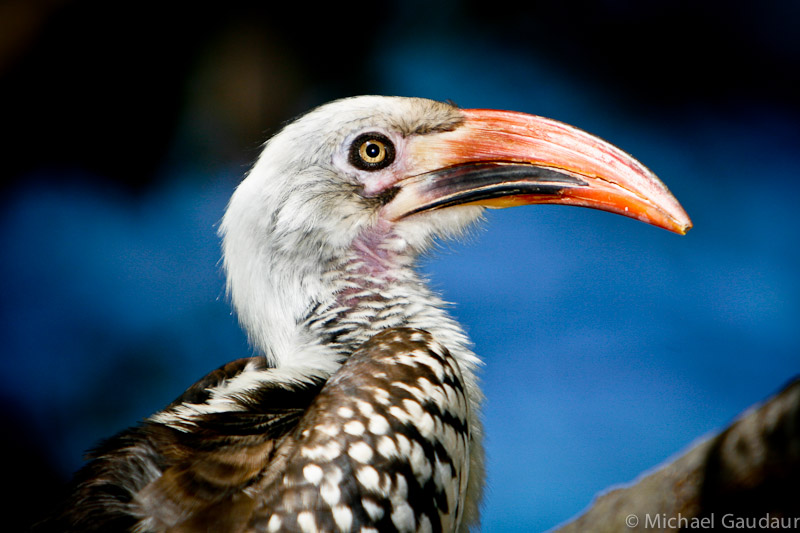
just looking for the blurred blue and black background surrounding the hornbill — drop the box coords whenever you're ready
[0,0,800,531]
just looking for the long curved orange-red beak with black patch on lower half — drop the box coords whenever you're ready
[384,109,692,234]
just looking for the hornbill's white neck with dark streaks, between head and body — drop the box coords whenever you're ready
[222,210,480,406]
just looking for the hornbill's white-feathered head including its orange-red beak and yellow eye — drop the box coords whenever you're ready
[220,96,691,368]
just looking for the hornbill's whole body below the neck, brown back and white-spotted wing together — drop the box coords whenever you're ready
[43,327,471,532]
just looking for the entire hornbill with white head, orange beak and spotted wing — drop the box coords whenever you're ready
[49,96,691,532]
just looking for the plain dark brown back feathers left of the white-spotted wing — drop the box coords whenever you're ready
[37,358,322,532]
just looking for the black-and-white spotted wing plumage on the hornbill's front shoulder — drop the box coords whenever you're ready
[251,328,470,532]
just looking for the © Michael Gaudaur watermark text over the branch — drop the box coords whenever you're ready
[625,513,800,530]
